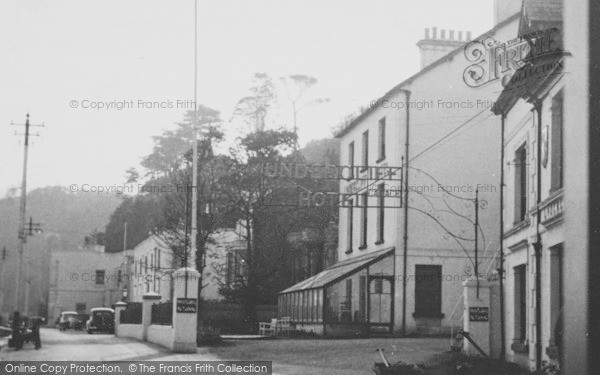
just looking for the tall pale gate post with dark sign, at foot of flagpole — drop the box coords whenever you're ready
[172,267,200,353]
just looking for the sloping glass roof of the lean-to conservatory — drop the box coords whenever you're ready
[279,248,394,294]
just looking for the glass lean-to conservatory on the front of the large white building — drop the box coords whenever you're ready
[278,248,394,337]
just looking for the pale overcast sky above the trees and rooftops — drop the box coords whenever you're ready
[0,0,493,197]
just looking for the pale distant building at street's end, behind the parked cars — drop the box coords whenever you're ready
[48,246,124,324]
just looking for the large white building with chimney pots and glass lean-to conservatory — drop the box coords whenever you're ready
[279,1,520,336]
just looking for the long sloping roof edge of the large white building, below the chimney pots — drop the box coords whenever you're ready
[334,12,521,138]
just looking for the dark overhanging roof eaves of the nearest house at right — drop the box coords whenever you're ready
[492,51,568,115]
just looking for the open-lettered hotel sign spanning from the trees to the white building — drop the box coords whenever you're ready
[261,163,402,208]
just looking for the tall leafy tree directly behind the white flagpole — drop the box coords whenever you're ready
[106,105,231,302]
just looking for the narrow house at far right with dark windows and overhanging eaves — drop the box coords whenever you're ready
[493,0,568,369]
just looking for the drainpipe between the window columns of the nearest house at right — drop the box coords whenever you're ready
[533,100,542,371]
